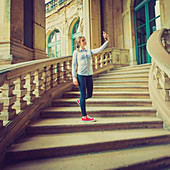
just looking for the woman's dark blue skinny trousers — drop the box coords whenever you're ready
[77,75,93,116]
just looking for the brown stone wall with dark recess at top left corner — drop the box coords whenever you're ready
[0,0,47,65]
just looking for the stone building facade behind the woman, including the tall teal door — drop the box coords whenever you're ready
[46,0,170,65]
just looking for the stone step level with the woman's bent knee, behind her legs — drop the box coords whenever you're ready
[63,91,150,99]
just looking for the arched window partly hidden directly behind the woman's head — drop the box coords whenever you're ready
[71,20,81,53]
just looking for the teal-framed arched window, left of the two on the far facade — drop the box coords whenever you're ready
[47,30,61,58]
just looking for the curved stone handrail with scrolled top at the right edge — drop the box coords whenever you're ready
[147,29,170,129]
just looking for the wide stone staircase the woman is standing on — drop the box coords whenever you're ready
[4,64,170,170]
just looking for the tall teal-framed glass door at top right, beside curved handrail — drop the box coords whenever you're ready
[135,0,161,64]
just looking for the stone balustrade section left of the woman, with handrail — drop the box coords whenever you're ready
[0,56,72,120]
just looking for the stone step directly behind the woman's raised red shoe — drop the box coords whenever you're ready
[52,98,152,109]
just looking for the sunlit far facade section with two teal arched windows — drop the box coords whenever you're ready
[46,0,83,57]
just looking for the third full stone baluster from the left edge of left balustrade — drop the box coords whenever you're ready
[24,72,36,105]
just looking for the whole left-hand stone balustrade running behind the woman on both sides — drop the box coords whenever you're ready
[0,48,129,125]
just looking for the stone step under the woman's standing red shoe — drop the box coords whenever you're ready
[26,117,163,135]
